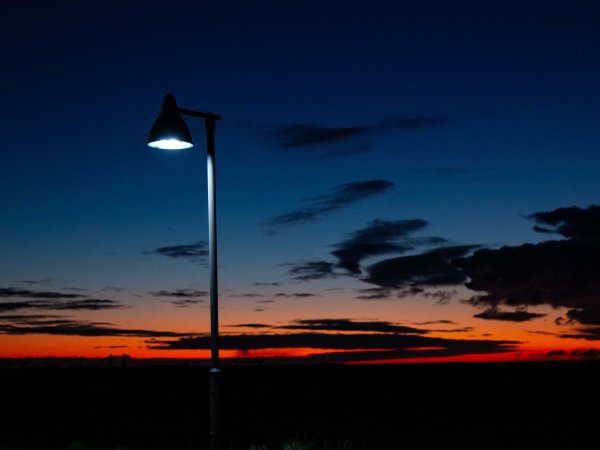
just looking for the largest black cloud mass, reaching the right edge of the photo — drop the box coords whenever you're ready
[454,205,600,326]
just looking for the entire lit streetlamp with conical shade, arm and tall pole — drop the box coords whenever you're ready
[148,94,222,450]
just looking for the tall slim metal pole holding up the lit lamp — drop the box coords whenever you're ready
[205,114,221,450]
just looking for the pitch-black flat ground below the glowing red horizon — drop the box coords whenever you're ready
[0,361,600,450]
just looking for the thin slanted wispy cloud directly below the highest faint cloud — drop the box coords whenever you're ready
[265,180,394,229]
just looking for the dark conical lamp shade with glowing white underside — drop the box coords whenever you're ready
[148,94,194,150]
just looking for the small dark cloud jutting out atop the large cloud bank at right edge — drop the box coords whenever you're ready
[529,205,600,239]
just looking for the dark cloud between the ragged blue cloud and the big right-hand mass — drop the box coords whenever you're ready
[363,245,477,289]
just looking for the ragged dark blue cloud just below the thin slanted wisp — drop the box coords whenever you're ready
[331,219,446,274]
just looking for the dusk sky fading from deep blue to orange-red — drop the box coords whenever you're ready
[0,0,600,363]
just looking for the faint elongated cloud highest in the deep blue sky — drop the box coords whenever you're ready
[267,116,446,157]
